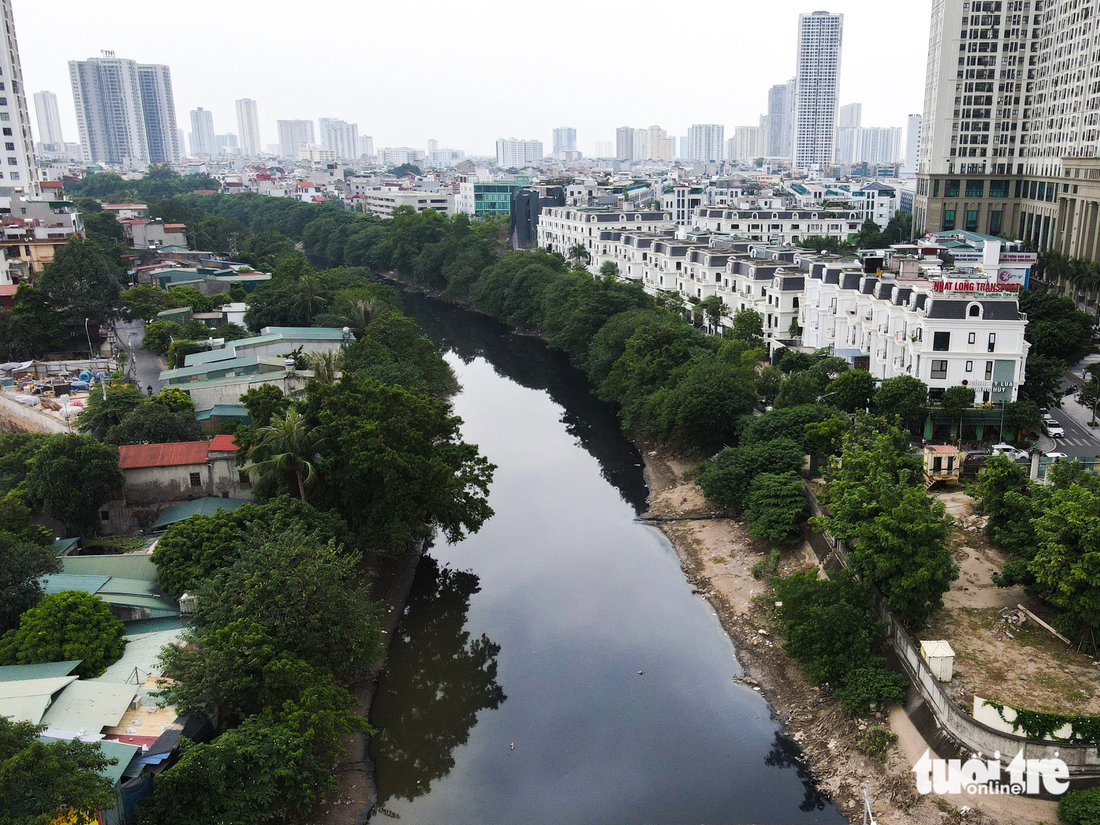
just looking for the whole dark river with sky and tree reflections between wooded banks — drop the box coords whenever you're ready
[371,295,846,825]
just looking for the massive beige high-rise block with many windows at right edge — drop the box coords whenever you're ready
[913,0,1100,261]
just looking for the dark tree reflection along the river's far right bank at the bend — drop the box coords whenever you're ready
[400,290,649,514]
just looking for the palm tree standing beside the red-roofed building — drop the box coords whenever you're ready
[244,407,326,501]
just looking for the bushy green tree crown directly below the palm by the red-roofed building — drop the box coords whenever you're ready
[153,496,354,598]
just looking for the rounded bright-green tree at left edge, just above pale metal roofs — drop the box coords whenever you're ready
[0,590,127,679]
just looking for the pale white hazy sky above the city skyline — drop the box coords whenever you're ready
[13,0,932,154]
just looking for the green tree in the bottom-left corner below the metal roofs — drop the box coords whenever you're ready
[0,714,118,825]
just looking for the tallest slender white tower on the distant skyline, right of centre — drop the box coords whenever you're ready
[794,11,844,172]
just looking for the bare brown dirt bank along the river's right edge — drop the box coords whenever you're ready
[640,444,1020,825]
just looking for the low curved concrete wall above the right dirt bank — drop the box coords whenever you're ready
[806,487,1100,780]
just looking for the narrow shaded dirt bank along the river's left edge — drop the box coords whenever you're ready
[314,545,425,825]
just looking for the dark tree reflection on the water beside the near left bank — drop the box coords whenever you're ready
[371,556,506,809]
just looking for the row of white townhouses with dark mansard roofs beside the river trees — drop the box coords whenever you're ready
[538,207,1030,404]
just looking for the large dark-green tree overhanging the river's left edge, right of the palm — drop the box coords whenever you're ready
[303,374,495,550]
